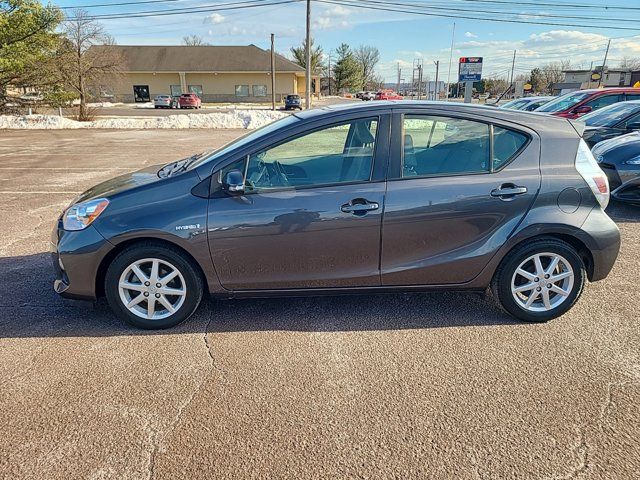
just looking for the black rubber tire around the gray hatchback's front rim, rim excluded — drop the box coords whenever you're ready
[104,242,204,330]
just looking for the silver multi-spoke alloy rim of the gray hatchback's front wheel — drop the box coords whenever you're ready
[118,258,187,320]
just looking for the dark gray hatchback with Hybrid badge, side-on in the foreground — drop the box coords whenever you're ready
[52,101,620,328]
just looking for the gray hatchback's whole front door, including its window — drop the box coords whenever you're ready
[208,116,388,290]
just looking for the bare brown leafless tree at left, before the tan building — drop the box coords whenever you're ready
[56,10,123,121]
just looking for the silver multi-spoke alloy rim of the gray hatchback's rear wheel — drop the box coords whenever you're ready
[511,252,575,312]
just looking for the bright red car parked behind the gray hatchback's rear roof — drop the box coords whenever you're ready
[535,87,640,118]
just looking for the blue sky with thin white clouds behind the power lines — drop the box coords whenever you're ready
[55,0,640,82]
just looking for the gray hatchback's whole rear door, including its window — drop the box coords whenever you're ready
[381,110,540,285]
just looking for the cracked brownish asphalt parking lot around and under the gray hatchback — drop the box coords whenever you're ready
[0,130,640,479]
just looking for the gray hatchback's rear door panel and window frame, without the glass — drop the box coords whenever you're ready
[381,112,540,285]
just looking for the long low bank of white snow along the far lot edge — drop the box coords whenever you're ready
[0,110,288,130]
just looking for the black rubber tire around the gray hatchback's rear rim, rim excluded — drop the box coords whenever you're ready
[491,238,587,322]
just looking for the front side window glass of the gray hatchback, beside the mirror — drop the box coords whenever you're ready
[222,118,378,192]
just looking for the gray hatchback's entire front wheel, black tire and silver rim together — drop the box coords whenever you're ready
[105,243,204,329]
